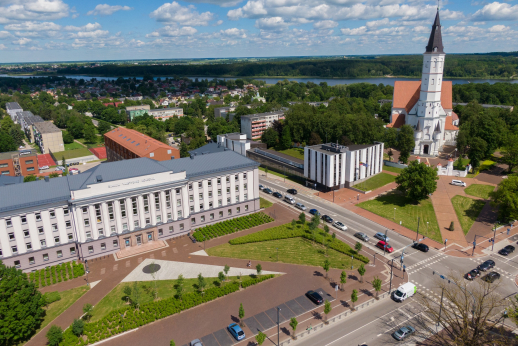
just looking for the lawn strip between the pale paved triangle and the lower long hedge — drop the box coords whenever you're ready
[92,276,264,321]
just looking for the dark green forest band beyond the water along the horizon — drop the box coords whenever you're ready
[58,53,518,79]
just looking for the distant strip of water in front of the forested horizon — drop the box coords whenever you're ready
[0,74,518,86]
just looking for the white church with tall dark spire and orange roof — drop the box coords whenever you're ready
[387,10,459,156]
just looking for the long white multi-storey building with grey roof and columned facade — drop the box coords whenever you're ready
[0,150,260,272]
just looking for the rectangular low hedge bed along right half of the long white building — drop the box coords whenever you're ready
[192,212,274,241]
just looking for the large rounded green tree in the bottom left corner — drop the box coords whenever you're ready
[0,261,45,346]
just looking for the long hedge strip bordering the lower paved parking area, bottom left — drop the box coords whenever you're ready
[59,275,274,346]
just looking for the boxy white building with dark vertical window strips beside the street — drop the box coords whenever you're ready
[304,142,383,190]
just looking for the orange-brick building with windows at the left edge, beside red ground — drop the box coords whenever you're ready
[0,150,40,177]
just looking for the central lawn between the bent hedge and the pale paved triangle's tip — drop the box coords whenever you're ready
[206,237,362,269]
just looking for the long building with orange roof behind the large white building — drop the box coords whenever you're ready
[104,127,180,161]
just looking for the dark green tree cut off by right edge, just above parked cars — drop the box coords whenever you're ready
[490,176,518,220]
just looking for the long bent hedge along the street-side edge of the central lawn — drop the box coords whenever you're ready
[229,223,369,263]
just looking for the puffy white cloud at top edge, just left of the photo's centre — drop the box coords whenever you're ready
[150,1,214,26]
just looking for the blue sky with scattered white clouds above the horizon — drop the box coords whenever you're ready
[0,0,518,63]
